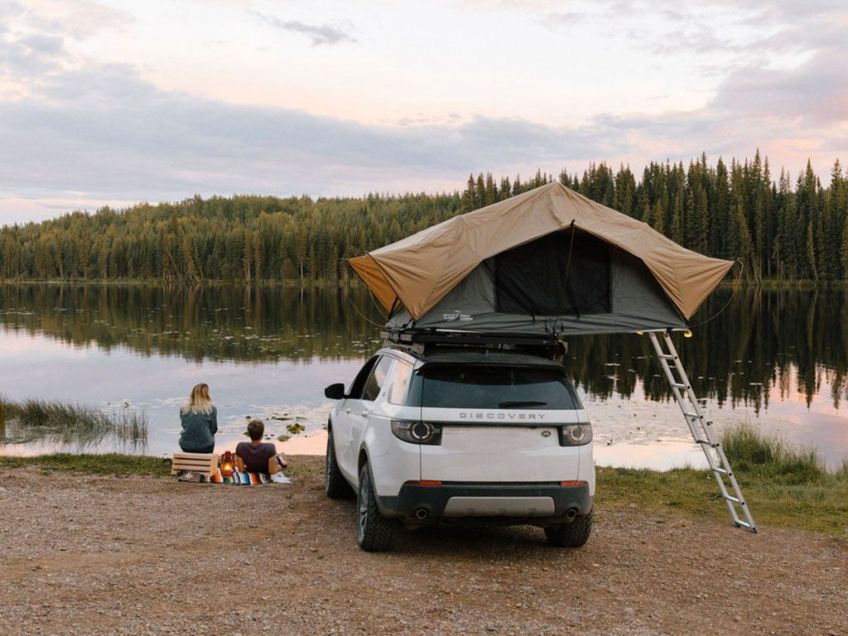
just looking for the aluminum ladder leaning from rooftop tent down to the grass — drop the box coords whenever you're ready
[648,331,757,532]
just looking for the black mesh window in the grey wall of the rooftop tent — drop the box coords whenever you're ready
[495,230,612,316]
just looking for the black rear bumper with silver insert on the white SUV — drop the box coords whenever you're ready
[377,482,592,525]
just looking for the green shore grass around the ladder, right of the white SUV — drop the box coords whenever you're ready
[597,425,848,538]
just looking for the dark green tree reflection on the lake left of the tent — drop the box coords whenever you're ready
[0,285,382,362]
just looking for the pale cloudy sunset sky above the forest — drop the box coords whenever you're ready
[0,0,848,224]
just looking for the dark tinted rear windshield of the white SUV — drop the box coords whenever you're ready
[407,365,580,410]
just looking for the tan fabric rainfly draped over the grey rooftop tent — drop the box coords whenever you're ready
[348,183,733,320]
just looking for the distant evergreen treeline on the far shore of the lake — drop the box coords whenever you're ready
[0,152,848,283]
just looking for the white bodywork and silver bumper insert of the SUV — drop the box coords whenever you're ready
[330,349,595,516]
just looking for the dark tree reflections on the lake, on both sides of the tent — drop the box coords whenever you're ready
[0,285,848,411]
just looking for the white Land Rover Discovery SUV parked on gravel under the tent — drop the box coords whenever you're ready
[324,348,595,551]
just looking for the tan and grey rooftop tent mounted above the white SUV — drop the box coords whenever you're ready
[349,183,733,336]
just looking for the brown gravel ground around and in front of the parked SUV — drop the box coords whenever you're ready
[0,457,848,635]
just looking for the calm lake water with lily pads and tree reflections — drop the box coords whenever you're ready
[0,285,848,468]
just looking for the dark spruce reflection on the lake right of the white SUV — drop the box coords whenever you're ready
[569,289,848,414]
